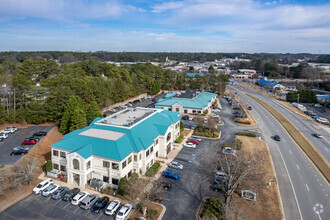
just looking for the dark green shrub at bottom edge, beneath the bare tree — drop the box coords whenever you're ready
[202,198,224,220]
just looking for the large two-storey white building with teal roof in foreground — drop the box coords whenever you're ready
[51,108,180,188]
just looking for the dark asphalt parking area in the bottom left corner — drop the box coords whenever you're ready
[0,194,119,220]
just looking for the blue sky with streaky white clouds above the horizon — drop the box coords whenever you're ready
[0,0,330,54]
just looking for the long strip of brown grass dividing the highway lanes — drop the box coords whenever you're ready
[246,94,330,183]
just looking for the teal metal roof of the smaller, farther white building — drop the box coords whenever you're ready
[156,92,217,109]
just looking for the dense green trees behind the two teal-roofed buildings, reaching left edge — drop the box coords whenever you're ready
[0,58,228,133]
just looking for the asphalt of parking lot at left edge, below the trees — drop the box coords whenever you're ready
[0,126,52,165]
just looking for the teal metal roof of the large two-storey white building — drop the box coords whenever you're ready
[51,110,180,161]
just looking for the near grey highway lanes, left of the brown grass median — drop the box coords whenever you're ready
[229,88,330,220]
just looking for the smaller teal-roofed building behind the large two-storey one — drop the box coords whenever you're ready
[155,90,217,114]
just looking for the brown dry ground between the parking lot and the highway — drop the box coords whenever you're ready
[233,136,281,220]
